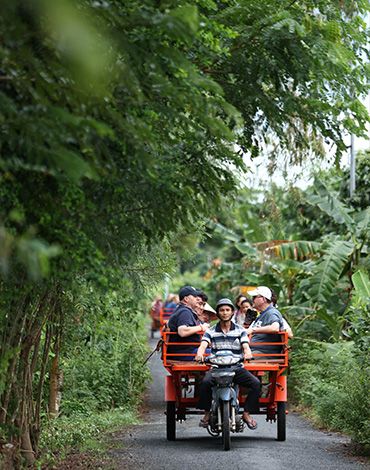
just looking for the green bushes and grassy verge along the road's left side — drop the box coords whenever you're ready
[33,284,148,465]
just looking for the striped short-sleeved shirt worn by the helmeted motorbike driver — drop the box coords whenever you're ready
[202,322,249,354]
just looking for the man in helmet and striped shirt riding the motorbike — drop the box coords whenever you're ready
[195,298,261,429]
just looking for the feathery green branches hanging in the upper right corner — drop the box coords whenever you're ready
[212,0,369,161]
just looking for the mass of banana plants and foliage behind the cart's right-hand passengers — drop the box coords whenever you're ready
[195,170,370,339]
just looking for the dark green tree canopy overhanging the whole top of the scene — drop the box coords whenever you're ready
[0,0,369,272]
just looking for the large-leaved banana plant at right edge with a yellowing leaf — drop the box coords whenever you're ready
[269,180,370,339]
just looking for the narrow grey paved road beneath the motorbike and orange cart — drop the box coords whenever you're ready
[110,334,368,470]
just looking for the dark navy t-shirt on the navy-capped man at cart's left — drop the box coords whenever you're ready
[167,304,201,359]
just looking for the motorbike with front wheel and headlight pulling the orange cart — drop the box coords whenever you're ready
[205,351,244,450]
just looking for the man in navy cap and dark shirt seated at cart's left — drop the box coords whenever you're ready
[167,286,209,361]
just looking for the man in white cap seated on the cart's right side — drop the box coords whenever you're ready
[247,286,284,357]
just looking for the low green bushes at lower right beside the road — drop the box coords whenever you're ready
[290,342,370,452]
